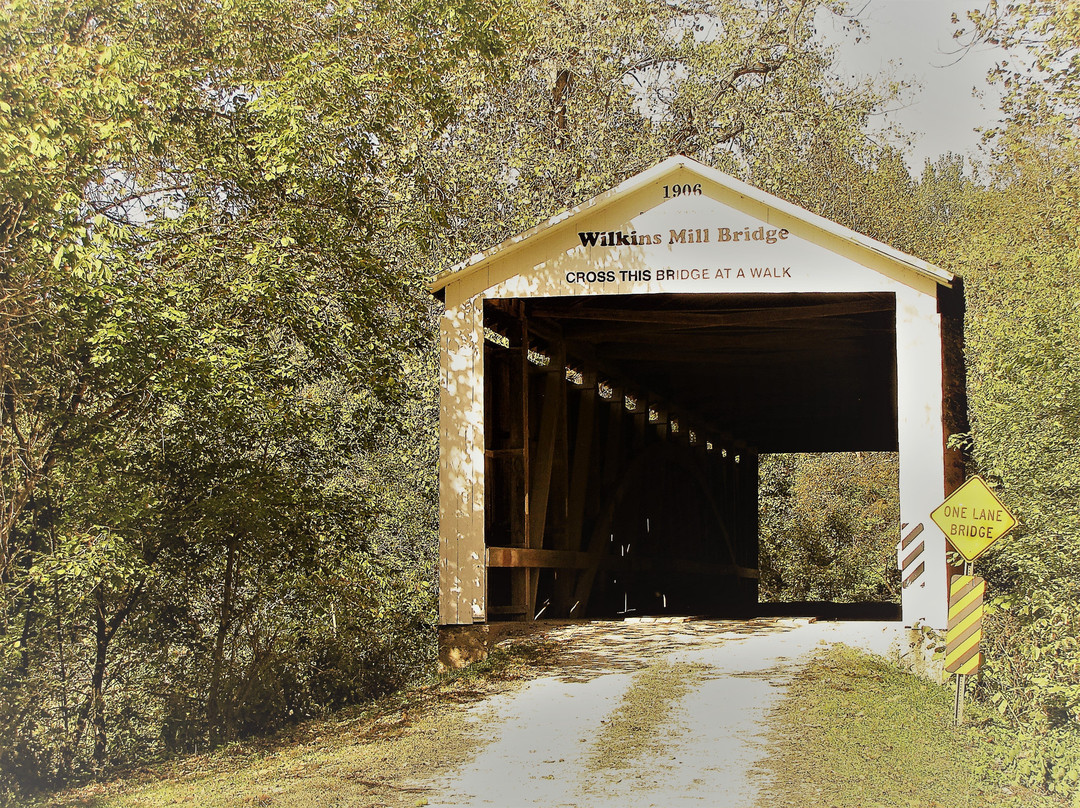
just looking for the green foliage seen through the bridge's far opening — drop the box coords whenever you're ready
[758,453,900,603]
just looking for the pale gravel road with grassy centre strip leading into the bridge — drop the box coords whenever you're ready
[416,619,897,808]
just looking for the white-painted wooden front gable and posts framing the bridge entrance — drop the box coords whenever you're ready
[433,158,951,629]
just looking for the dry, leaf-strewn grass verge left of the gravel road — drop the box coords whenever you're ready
[30,641,556,808]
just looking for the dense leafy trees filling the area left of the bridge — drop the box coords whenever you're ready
[0,0,517,791]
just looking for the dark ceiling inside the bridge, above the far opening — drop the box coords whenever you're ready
[524,294,896,453]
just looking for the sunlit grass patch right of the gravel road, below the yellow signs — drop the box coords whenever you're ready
[759,646,1064,808]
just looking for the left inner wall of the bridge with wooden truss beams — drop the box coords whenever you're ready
[486,301,757,619]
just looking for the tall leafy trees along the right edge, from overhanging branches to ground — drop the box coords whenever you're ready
[946,0,1080,794]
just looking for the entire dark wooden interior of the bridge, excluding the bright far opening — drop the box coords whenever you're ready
[485,294,896,620]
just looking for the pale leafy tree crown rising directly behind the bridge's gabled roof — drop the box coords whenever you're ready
[412,0,888,262]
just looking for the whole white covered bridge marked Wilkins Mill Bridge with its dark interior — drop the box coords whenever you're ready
[425,157,966,661]
